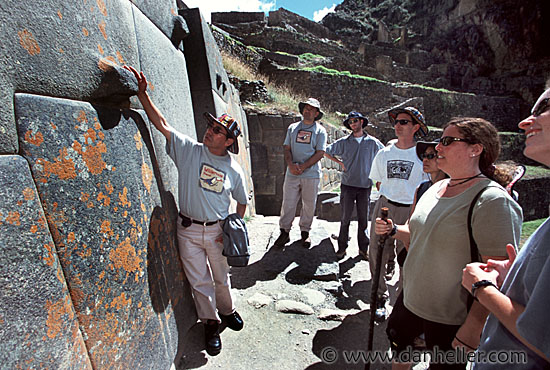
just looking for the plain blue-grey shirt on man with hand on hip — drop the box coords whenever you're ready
[327,134,384,188]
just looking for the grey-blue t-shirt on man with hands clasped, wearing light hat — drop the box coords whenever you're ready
[283,121,327,179]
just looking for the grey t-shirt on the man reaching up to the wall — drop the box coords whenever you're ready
[166,132,248,221]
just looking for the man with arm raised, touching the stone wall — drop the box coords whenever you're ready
[124,66,248,356]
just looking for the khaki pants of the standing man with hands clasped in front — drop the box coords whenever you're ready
[279,175,320,232]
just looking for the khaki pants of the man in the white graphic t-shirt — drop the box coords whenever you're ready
[369,196,411,299]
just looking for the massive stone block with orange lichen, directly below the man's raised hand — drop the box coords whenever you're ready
[15,94,196,369]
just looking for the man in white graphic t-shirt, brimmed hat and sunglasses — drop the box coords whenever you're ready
[369,107,429,321]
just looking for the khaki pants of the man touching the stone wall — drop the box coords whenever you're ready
[177,217,235,322]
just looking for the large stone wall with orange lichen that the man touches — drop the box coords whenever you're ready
[0,0,253,369]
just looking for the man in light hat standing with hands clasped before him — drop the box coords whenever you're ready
[274,98,327,248]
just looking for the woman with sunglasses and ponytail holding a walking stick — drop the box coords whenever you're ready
[375,118,522,369]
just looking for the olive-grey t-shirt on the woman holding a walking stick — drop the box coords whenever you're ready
[403,179,523,325]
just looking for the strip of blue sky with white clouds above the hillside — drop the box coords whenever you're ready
[183,0,342,22]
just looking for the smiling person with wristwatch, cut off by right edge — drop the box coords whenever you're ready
[462,80,550,370]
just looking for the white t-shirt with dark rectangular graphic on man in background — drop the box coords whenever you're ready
[369,143,429,204]
